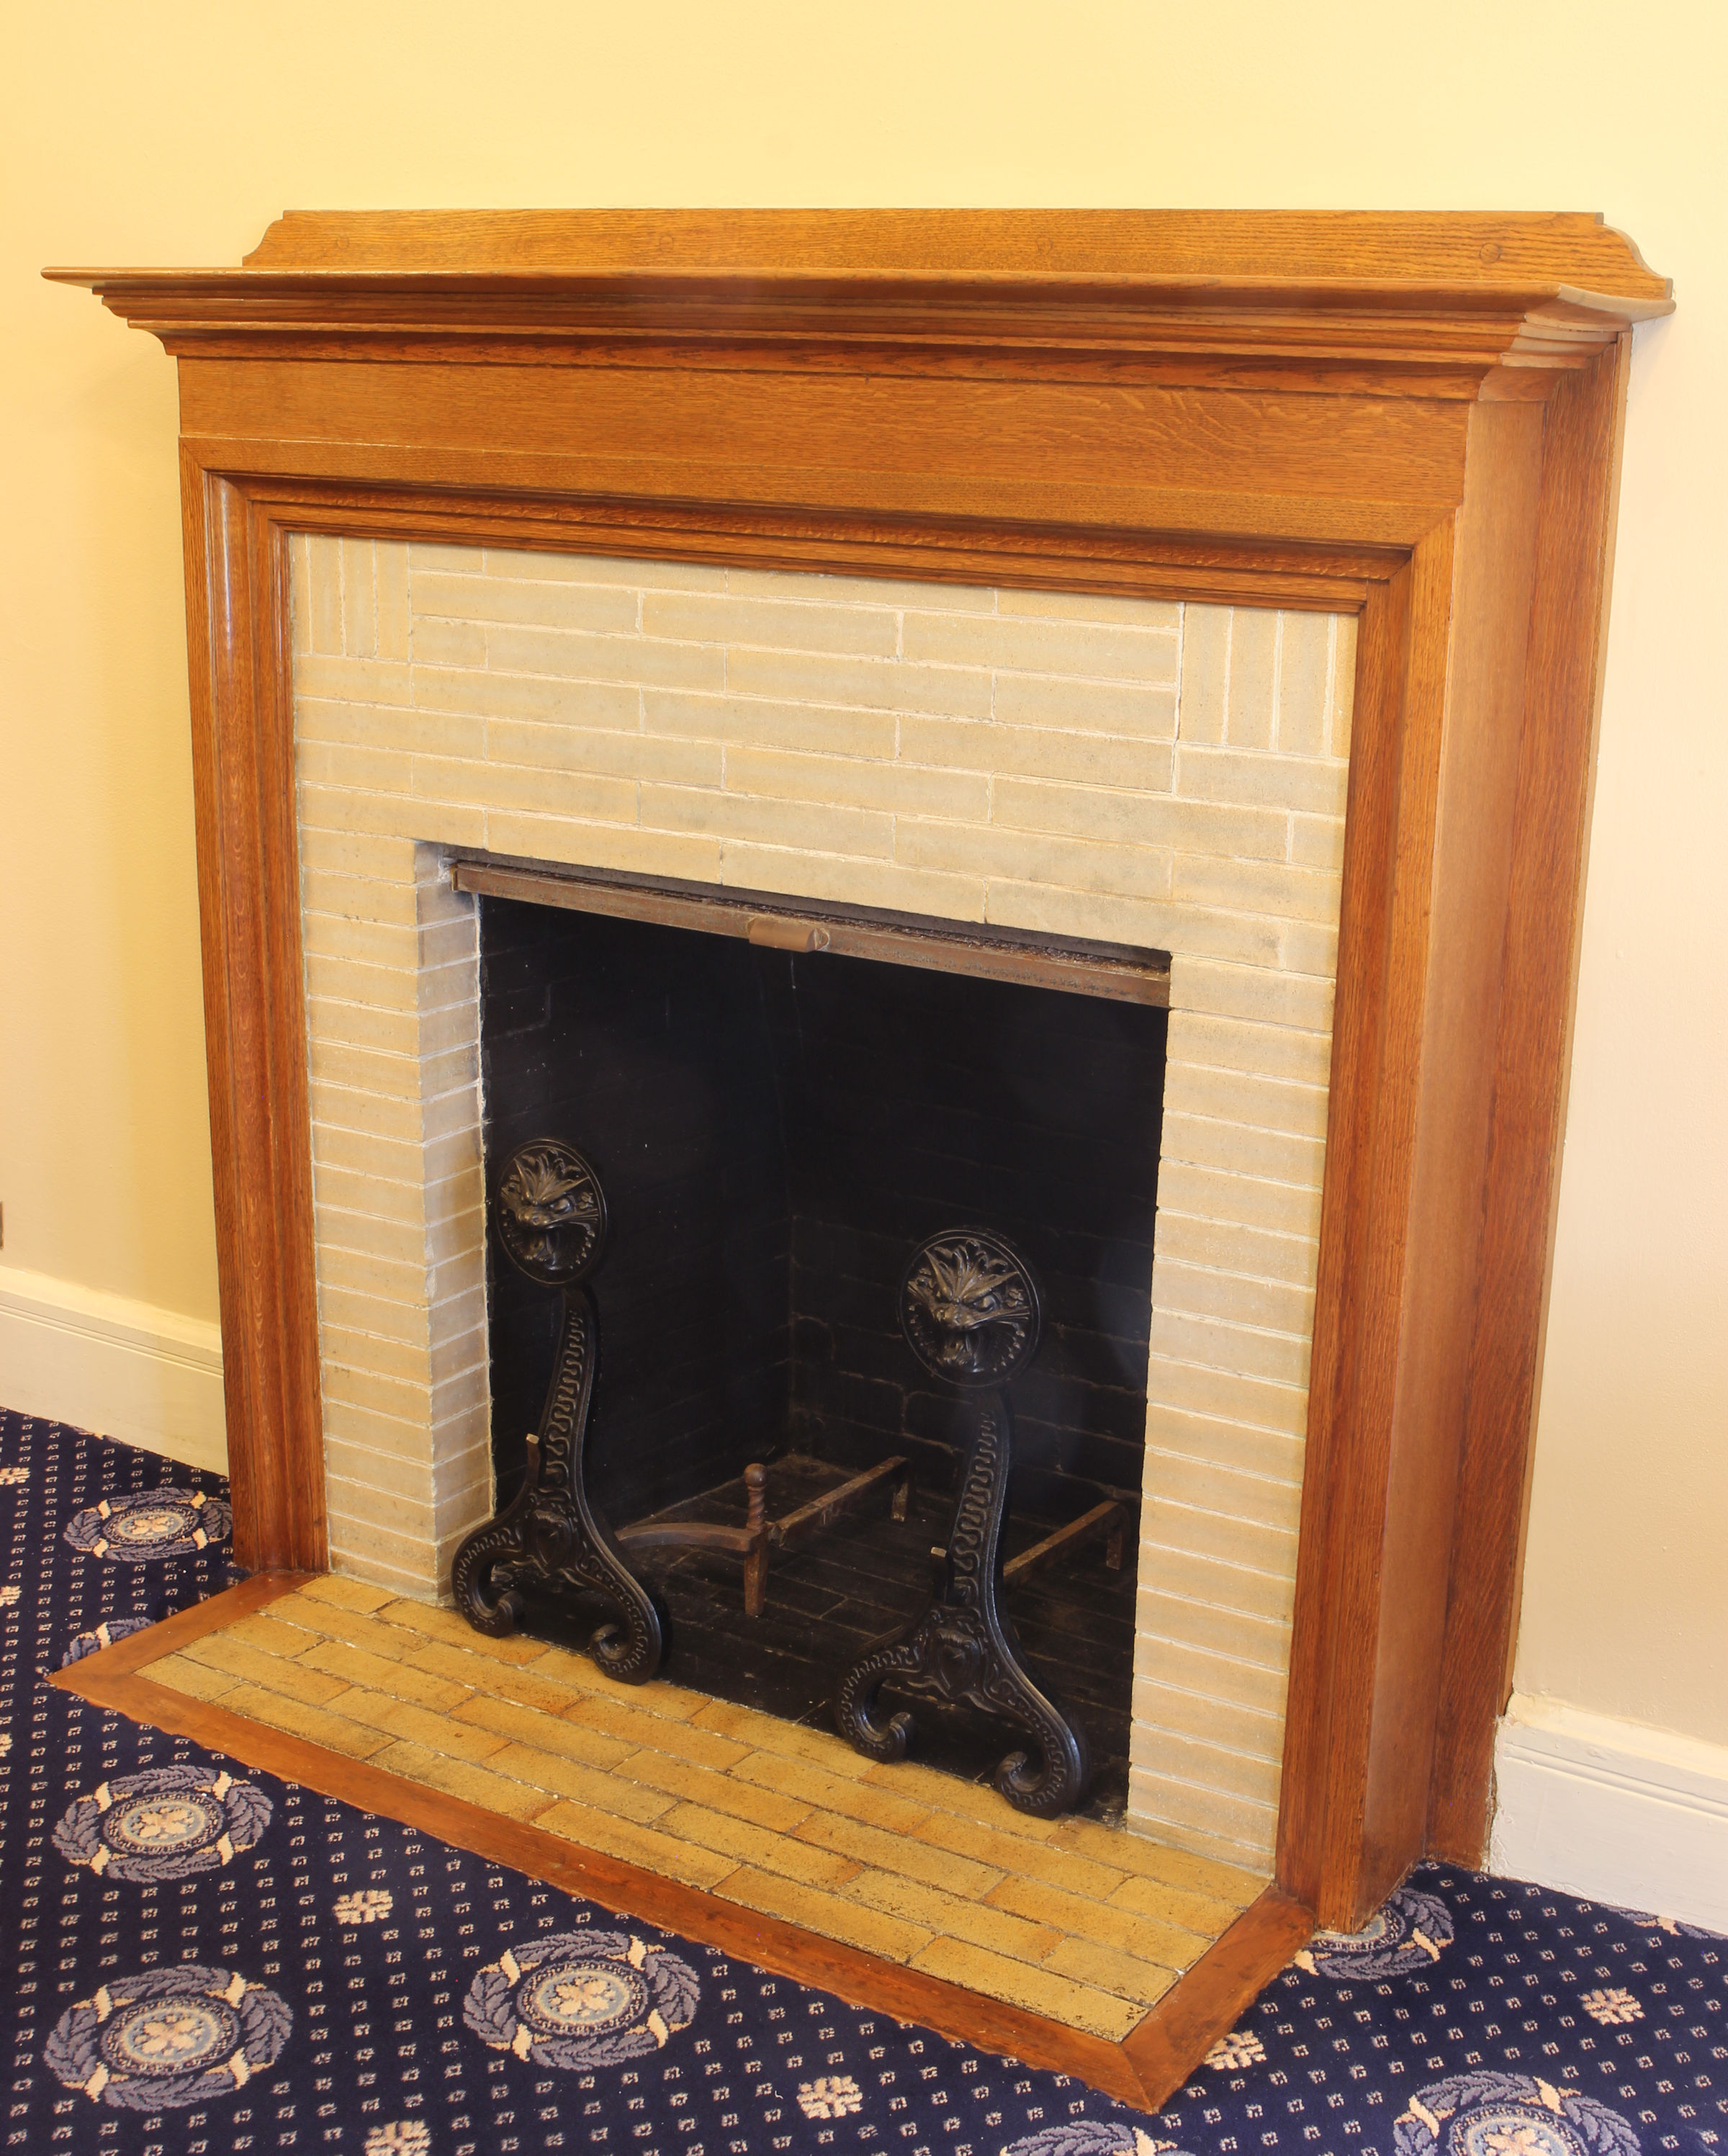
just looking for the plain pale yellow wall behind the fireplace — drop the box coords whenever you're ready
[0,0,1728,1740]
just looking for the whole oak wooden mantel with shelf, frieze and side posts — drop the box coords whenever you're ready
[50,211,1672,1957]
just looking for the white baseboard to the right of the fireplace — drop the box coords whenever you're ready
[1489,1692,1728,1932]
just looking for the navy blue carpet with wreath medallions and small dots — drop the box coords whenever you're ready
[0,1414,1728,2156]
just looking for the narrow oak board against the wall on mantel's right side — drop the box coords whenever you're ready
[1428,338,1631,1865]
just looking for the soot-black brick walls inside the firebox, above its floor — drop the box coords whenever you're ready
[480,899,1166,1527]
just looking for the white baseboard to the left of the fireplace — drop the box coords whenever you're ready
[0,1265,228,1475]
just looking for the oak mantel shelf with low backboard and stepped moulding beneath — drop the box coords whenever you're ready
[45,209,1672,381]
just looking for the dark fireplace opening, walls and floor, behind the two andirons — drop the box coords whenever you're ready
[480,897,1166,1818]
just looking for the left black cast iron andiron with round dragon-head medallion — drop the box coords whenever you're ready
[450,1138,662,1684]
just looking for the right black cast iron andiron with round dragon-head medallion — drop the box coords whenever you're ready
[834,1227,1090,1820]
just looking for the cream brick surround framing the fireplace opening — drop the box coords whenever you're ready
[293,539,1355,1872]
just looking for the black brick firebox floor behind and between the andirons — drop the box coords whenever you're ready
[526,1453,1135,1820]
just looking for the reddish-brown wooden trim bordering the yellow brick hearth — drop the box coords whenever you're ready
[50,1572,1314,2111]
